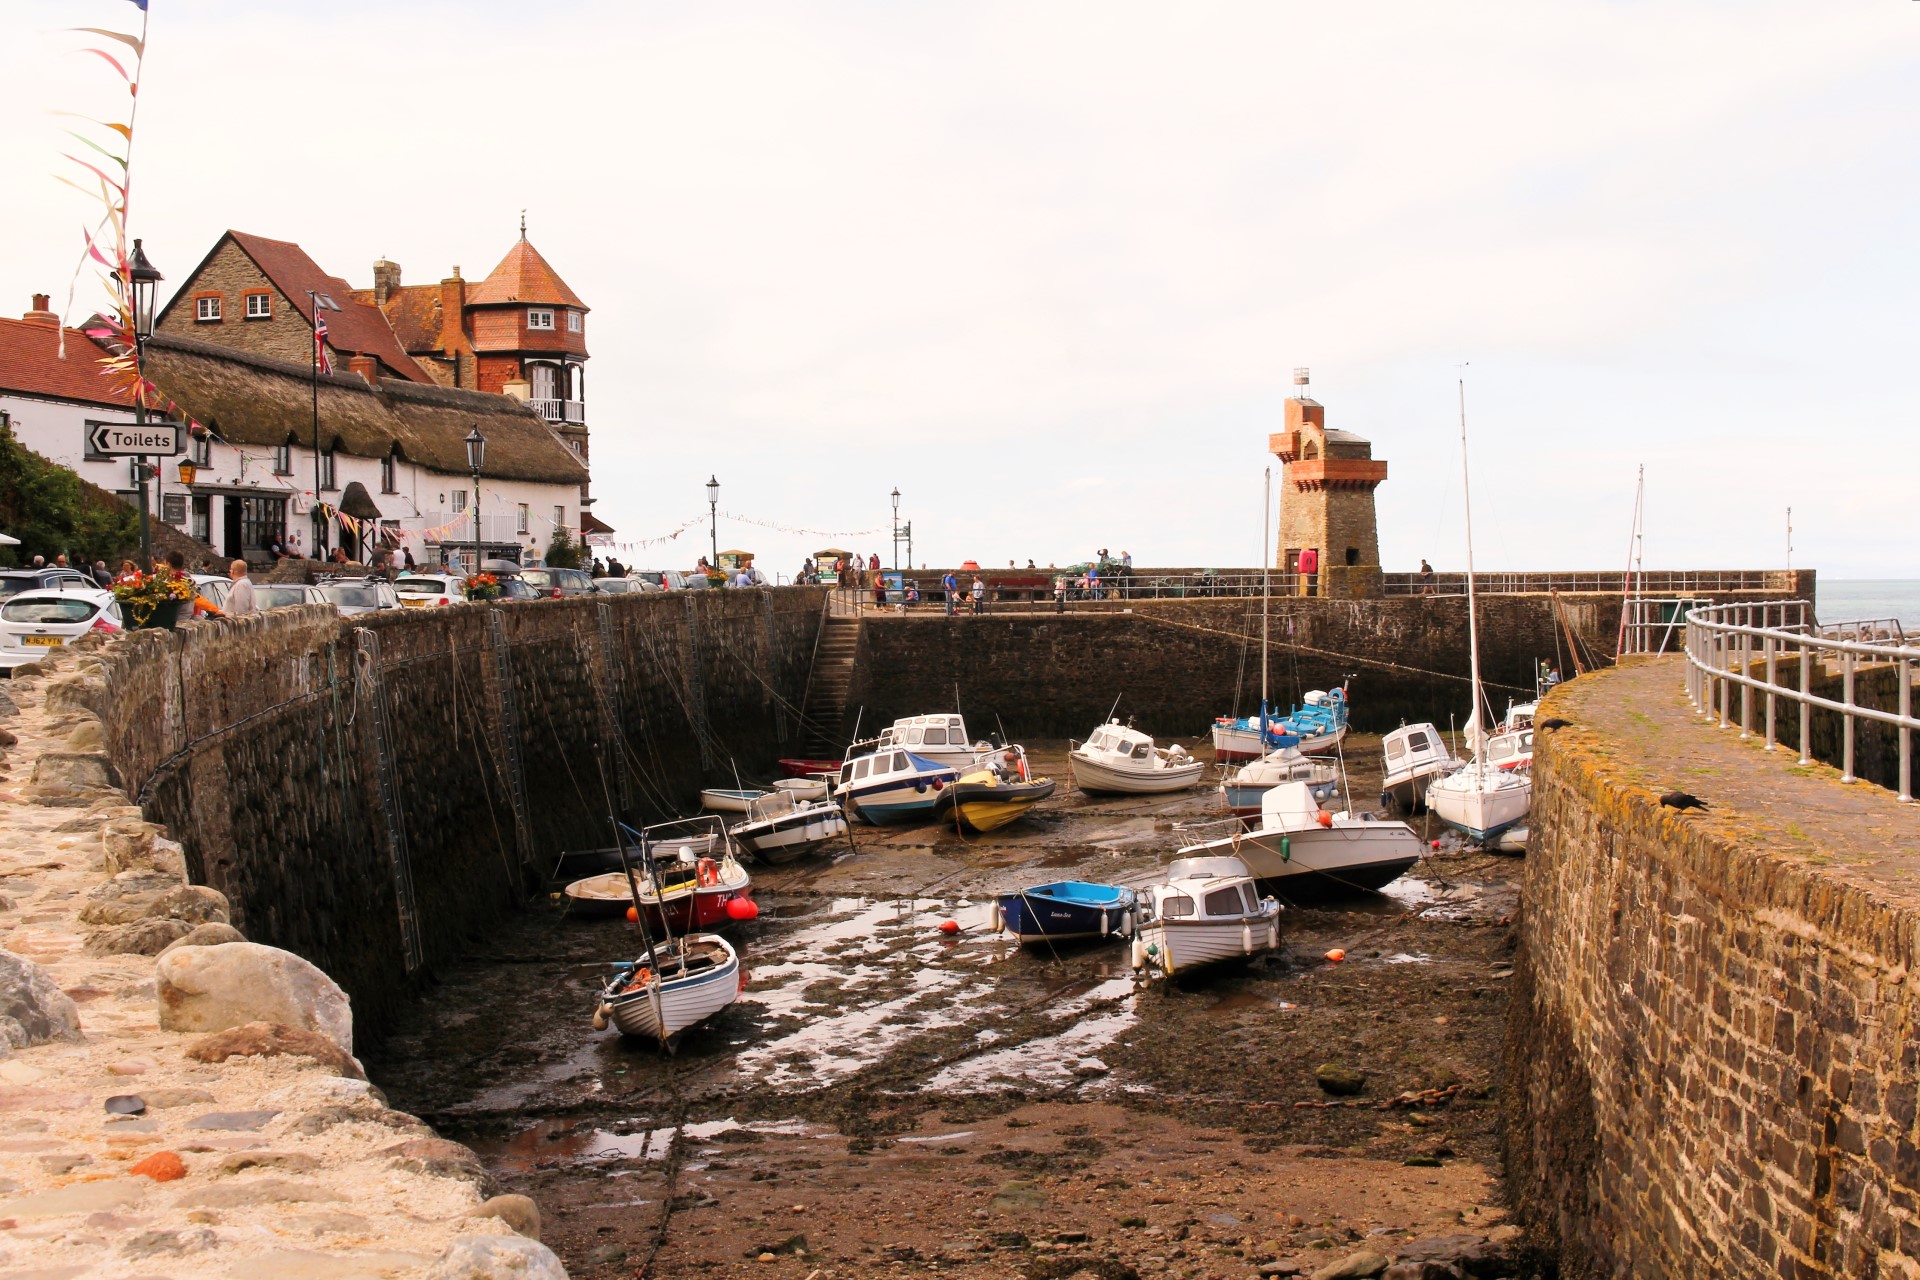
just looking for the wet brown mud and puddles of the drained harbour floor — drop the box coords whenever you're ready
[371,739,1532,1280]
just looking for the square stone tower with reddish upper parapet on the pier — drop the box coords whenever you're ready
[1267,368,1386,595]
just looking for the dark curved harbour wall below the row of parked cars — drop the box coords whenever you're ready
[61,587,822,1038]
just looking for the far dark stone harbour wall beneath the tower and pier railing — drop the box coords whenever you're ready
[845,595,1789,739]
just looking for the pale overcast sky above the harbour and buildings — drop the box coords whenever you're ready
[0,0,1920,578]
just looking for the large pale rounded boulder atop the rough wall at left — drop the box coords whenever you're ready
[154,942,353,1054]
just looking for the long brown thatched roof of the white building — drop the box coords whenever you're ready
[146,334,588,484]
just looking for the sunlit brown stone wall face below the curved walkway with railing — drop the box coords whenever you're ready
[1505,666,1920,1278]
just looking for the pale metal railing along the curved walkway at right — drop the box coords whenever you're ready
[1686,601,1920,802]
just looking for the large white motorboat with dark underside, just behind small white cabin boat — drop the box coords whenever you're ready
[1181,783,1427,896]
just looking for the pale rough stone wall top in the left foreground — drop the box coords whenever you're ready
[0,654,564,1280]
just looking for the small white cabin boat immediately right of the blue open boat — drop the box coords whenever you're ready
[1133,856,1281,977]
